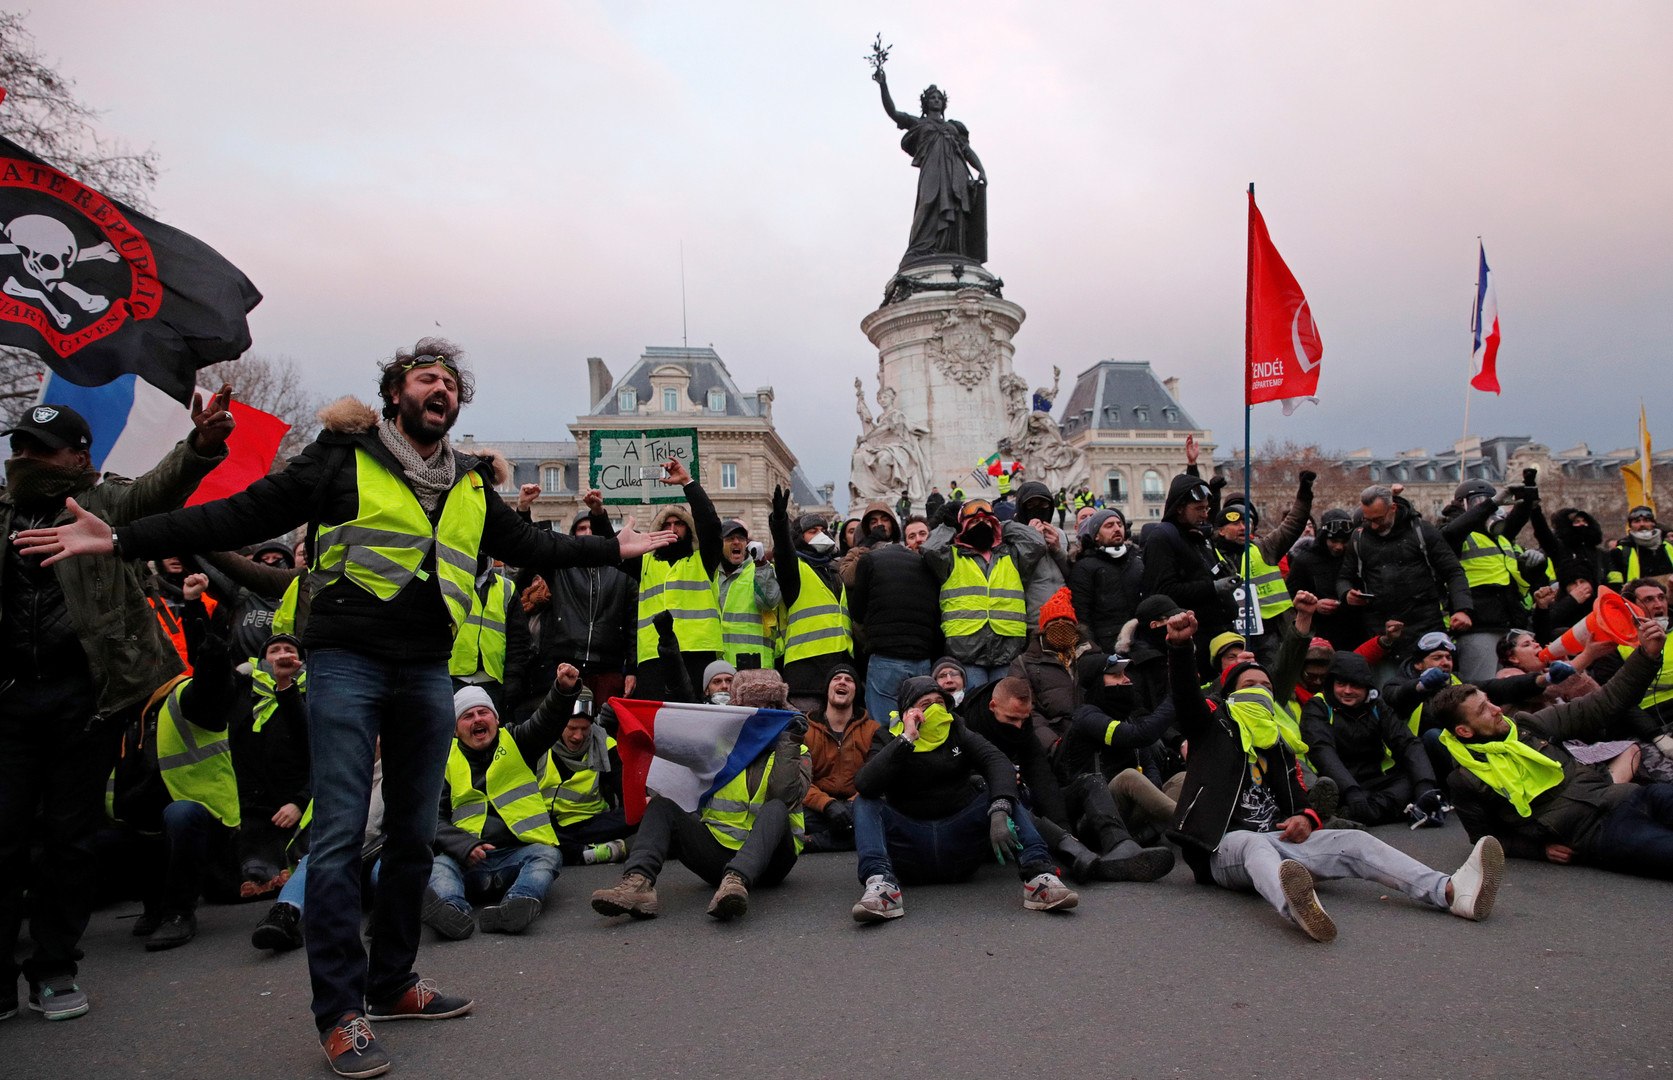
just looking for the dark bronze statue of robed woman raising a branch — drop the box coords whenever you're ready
[872,64,987,269]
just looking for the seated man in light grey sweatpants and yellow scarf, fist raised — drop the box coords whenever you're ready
[1168,615,1504,941]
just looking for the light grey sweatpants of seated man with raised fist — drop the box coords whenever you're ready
[1208,829,1450,918]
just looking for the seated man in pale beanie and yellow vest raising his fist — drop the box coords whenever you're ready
[423,664,581,941]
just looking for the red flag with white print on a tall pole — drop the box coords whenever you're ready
[1243,184,1325,416]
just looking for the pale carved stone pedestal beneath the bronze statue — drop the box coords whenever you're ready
[848,262,1026,507]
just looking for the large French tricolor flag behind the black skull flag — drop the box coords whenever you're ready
[38,371,291,507]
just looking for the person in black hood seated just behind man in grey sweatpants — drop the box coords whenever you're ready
[1302,652,1442,824]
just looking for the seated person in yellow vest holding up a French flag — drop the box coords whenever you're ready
[592,669,810,921]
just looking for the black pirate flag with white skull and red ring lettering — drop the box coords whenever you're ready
[0,139,261,401]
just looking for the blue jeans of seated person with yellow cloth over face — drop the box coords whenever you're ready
[853,791,1057,884]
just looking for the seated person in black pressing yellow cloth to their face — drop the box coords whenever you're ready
[853,677,1079,923]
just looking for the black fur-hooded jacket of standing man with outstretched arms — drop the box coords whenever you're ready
[117,400,621,660]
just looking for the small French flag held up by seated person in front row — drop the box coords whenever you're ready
[611,697,796,824]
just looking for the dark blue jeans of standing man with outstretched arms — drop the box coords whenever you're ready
[303,649,453,1032]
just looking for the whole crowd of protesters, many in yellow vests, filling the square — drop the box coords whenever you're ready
[0,339,1673,1077]
